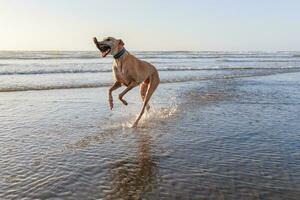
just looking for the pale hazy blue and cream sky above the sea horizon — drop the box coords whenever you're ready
[0,0,300,51]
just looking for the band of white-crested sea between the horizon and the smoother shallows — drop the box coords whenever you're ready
[0,51,300,92]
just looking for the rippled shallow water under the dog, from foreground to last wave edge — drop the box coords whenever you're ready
[0,73,300,199]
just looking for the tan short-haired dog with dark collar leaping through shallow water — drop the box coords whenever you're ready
[93,37,160,128]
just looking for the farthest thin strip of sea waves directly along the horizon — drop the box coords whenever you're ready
[0,51,300,60]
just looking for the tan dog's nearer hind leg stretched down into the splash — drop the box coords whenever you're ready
[132,71,160,127]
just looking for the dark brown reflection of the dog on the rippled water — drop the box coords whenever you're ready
[106,133,158,199]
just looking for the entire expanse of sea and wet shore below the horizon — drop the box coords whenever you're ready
[0,52,300,199]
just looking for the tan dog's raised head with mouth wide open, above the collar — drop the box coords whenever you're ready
[94,37,124,57]
